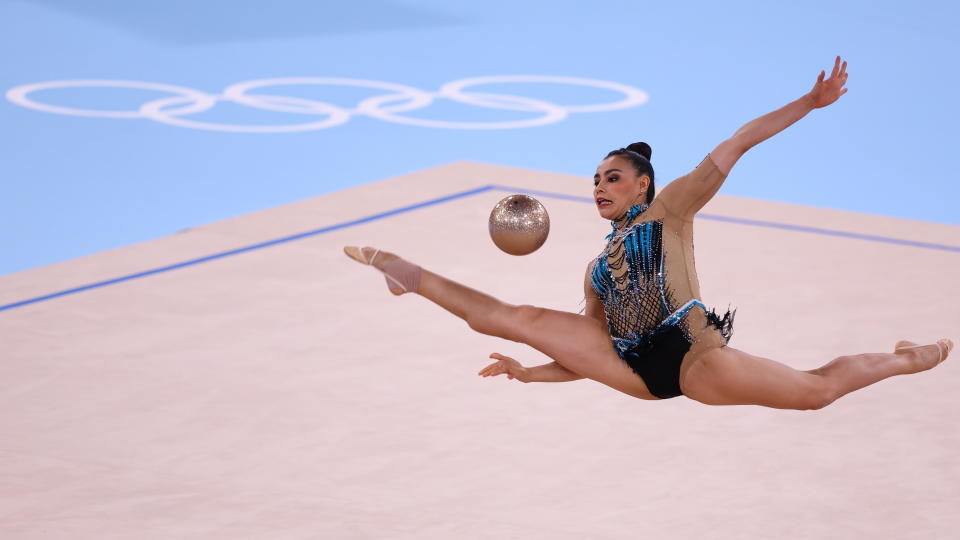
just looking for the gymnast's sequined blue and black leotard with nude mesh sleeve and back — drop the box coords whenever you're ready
[588,155,733,398]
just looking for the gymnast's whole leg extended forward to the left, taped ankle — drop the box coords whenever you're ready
[344,248,657,399]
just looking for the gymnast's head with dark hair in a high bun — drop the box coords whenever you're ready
[593,142,654,219]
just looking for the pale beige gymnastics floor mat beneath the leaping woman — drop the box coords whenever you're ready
[0,163,960,540]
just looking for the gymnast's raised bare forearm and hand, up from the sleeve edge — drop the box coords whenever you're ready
[710,56,847,176]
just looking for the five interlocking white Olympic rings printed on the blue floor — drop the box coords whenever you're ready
[6,75,647,133]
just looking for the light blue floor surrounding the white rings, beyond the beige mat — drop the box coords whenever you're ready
[0,0,960,274]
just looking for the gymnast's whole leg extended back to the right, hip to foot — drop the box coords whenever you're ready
[681,343,949,410]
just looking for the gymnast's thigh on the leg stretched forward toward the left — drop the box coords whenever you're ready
[515,306,657,399]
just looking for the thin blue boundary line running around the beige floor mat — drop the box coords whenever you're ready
[0,184,960,311]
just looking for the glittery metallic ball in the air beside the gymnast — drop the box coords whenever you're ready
[490,195,550,255]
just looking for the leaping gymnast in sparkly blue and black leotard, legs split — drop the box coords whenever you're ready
[344,56,953,410]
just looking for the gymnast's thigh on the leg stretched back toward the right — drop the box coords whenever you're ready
[681,347,830,409]
